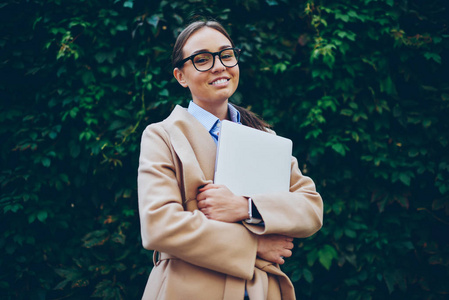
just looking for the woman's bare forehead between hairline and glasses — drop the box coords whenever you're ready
[183,27,232,55]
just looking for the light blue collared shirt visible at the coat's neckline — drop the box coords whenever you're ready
[187,101,242,144]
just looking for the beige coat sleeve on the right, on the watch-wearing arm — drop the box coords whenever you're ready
[245,157,323,238]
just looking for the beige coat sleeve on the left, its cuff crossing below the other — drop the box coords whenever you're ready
[138,124,257,279]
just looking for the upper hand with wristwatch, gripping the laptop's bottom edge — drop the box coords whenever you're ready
[196,183,248,223]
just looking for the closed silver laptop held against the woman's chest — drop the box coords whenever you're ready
[214,120,293,197]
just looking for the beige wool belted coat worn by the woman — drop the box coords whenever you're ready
[138,106,323,300]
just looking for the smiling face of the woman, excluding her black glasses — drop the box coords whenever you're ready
[173,27,239,111]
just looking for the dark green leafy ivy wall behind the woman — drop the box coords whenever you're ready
[0,0,449,299]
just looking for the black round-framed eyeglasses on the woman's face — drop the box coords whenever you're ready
[176,48,242,72]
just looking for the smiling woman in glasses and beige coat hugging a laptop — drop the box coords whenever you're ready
[138,21,323,300]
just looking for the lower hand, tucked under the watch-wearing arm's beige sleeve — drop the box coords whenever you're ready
[257,234,294,265]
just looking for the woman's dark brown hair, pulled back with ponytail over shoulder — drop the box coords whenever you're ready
[172,20,270,131]
